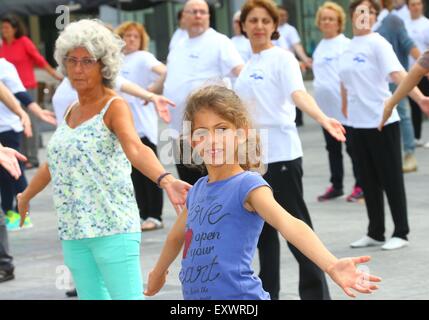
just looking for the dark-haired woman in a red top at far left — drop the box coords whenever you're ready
[0,15,63,168]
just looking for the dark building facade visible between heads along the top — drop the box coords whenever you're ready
[0,0,429,64]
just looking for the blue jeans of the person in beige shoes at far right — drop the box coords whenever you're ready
[389,83,416,154]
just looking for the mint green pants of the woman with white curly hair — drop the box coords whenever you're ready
[61,233,144,300]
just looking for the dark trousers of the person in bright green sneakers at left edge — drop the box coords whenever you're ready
[0,130,27,213]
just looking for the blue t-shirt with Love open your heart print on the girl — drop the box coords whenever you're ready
[179,171,270,300]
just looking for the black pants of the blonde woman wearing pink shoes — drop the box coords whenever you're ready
[322,126,362,190]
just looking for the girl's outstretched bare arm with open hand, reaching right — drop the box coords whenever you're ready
[246,187,381,297]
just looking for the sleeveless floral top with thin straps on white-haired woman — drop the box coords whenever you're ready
[47,97,141,240]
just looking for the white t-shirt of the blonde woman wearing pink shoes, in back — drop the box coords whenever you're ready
[313,34,350,125]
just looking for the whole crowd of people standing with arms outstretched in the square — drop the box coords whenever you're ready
[0,0,429,300]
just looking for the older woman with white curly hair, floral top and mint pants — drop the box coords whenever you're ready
[18,20,190,300]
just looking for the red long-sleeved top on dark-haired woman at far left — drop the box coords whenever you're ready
[0,36,48,89]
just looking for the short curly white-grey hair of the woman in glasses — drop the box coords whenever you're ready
[54,19,125,88]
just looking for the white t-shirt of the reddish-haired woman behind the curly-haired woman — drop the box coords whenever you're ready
[120,51,161,145]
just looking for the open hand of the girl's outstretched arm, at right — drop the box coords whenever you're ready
[327,256,381,298]
